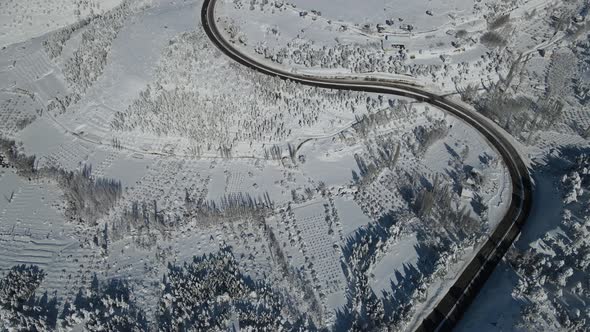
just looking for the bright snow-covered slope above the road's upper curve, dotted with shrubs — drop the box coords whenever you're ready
[218,0,491,67]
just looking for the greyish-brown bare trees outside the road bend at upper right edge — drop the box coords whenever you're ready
[476,39,588,142]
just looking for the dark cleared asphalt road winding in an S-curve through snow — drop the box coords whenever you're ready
[201,0,533,331]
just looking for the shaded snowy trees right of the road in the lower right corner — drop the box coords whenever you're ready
[508,149,590,331]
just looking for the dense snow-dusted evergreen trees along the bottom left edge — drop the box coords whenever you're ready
[0,252,316,332]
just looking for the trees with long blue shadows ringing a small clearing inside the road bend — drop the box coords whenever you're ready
[337,169,485,331]
